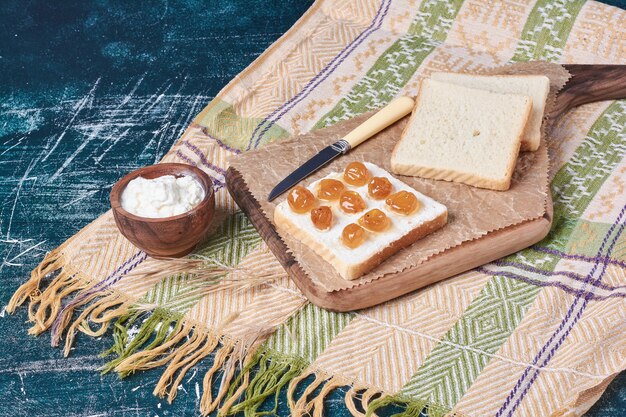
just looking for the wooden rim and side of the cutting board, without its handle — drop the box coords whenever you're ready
[226,168,552,311]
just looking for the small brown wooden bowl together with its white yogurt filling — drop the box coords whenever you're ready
[110,163,215,258]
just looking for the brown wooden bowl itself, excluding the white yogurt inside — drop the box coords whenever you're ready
[110,164,215,258]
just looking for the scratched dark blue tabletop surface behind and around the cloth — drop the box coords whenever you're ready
[0,0,626,416]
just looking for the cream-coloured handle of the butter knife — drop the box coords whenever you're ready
[343,97,415,148]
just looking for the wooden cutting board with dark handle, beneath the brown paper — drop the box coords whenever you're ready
[226,65,626,311]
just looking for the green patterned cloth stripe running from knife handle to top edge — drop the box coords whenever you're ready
[314,0,463,129]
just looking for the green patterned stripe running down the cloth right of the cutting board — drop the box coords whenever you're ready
[392,102,626,409]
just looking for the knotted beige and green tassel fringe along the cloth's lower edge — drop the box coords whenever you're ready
[7,246,458,417]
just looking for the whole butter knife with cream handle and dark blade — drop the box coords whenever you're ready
[267,97,415,201]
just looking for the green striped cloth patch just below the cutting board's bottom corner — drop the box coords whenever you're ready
[266,303,354,363]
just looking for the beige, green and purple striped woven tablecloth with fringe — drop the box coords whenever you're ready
[7,0,626,416]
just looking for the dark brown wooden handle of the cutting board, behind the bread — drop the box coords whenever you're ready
[550,64,626,119]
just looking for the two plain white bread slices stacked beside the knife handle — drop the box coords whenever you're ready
[391,73,550,190]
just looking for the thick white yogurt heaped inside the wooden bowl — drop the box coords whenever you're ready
[122,175,204,218]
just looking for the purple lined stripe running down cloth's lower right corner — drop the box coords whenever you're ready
[496,206,626,417]
